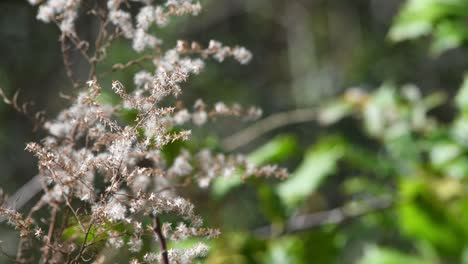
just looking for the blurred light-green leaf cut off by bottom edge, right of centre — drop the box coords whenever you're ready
[358,245,428,264]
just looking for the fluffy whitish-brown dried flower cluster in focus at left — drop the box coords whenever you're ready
[0,0,287,263]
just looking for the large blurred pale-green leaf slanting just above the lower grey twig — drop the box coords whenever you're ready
[277,137,345,207]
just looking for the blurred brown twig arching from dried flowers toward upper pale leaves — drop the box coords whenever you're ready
[223,108,317,151]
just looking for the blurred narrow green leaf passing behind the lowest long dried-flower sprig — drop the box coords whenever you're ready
[212,135,298,198]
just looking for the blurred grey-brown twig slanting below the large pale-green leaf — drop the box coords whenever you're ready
[253,196,394,238]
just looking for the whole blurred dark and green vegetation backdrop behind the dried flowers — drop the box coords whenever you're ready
[0,0,468,264]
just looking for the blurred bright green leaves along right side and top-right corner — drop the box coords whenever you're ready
[199,0,468,264]
